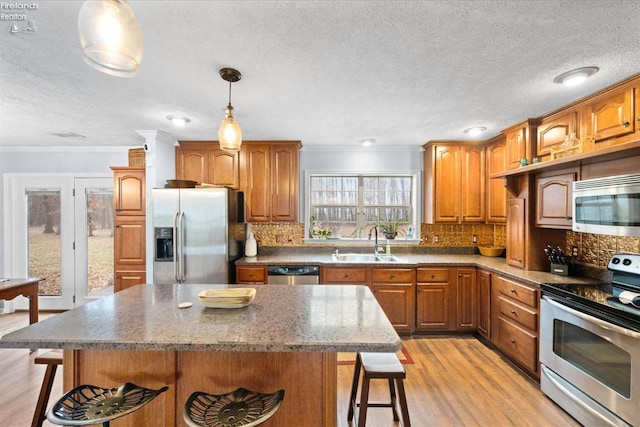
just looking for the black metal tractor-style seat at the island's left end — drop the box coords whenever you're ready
[47,383,169,427]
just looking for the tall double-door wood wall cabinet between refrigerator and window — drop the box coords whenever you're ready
[240,141,300,222]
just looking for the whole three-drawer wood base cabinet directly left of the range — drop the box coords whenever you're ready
[492,274,540,378]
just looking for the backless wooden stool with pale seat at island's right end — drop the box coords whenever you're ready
[347,353,411,427]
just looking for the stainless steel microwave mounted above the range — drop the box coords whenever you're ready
[572,174,640,236]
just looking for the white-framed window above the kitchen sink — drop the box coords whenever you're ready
[307,173,417,239]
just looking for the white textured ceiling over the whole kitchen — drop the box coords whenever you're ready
[0,0,640,148]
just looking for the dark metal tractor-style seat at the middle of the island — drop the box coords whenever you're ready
[182,388,284,427]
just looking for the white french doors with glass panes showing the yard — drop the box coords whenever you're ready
[5,174,113,310]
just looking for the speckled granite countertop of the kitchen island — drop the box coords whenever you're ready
[0,284,401,352]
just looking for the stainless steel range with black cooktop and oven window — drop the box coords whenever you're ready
[540,253,640,426]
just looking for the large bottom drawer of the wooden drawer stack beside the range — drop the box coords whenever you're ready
[498,317,538,373]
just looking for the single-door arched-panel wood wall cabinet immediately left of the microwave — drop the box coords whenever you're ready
[536,168,579,230]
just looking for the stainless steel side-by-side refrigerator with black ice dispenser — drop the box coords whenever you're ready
[152,188,244,284]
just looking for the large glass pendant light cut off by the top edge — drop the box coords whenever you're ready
[78,0,142,77]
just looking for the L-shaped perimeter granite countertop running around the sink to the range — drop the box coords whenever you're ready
[236,251,599,286]
